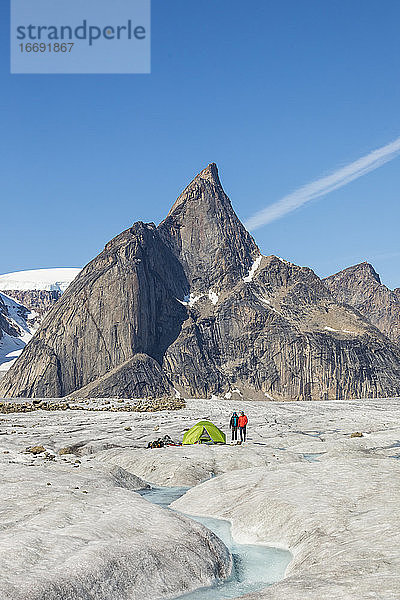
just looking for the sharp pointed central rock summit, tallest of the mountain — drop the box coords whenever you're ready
[158,163,260,292]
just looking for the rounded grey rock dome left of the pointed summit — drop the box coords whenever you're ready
[0,223,189,398]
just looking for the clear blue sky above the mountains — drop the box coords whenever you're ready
[0,0,400,287]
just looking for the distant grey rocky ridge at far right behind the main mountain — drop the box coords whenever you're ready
[324,262,400,347]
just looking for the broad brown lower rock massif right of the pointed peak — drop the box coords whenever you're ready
[164,256,400,400]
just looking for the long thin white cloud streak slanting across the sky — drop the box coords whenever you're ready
[245,137,400,231]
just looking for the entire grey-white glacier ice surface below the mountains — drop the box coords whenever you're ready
[0,399,400,600]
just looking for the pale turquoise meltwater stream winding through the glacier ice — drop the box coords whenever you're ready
[139,487,292,600]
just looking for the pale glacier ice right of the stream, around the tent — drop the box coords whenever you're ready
[99,399,400,600]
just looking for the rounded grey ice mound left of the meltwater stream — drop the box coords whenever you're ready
[0,440,231,600]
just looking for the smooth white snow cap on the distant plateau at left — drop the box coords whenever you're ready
[0,268,81,292]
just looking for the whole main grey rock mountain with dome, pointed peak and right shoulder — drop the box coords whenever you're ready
[0,165,400,400]
